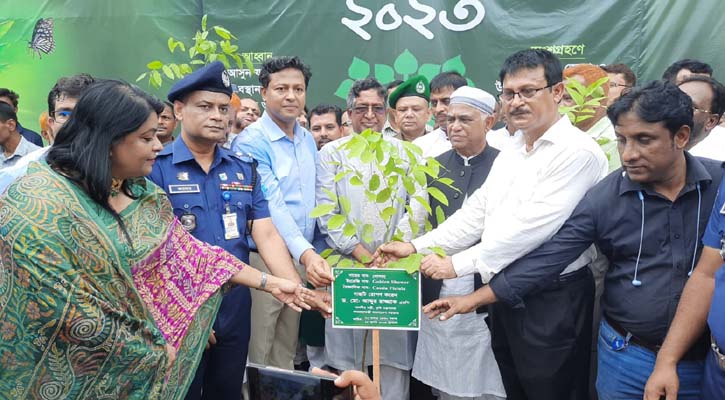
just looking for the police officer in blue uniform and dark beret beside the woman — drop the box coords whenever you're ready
[149,61,301,400]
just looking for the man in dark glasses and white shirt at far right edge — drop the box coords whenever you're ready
[677,75,725,161]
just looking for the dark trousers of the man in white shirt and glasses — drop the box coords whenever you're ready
[491,268,594,400]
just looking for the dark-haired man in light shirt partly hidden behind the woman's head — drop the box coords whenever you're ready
[0,74,95,193]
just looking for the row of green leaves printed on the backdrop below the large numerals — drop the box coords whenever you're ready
[335,49,475,99]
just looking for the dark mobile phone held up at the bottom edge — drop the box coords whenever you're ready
[247,363,354,400]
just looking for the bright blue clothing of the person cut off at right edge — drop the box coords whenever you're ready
[701,179,725,400]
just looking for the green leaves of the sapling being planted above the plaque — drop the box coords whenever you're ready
[310,130,453,273]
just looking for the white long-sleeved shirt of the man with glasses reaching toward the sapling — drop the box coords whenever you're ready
[412,117,607,282]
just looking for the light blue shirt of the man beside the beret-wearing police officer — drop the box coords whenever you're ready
[232,112,317,260]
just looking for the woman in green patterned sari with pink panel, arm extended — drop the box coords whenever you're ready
[0,81,313,399]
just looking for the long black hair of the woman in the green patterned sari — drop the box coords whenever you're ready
[46,80,164,244]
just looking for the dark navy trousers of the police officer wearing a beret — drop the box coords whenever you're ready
[185,286,252,400]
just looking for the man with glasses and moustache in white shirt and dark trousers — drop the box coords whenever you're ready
[376,49,607,400]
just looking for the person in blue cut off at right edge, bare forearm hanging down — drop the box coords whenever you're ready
[645,178,725,400]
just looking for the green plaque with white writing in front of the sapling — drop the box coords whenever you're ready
[332,268,420,330]
